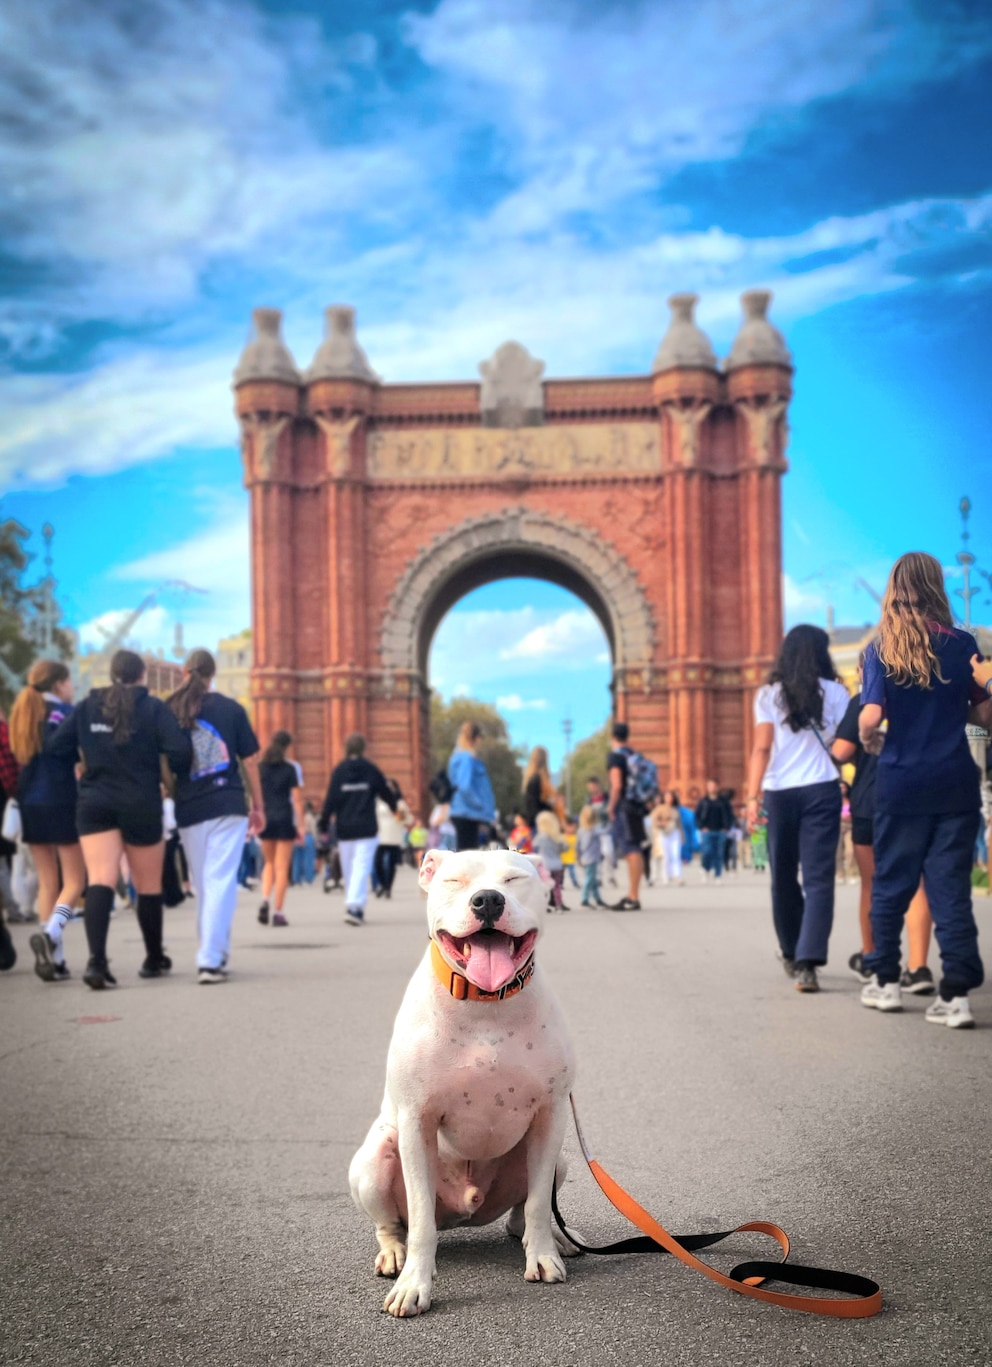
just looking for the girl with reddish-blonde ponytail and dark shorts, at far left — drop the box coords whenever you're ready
[10,660,86,983]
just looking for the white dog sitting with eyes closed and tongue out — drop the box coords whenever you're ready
[348,850,575,1316]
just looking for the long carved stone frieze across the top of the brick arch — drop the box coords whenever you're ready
[369,422,661,480]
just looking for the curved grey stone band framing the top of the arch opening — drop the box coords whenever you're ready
[380,507,656,673]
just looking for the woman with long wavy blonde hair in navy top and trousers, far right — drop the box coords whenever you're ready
[859,551,992,1029]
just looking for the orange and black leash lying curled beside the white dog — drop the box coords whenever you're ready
[551,1096,881,1319]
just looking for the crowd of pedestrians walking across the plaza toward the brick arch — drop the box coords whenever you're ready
[0,552,992,1028]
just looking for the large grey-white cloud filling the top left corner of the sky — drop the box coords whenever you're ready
[0,0,414,333]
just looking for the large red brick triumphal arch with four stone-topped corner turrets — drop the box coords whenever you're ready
[235,291,793,794]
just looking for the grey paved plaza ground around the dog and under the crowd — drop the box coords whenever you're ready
[0,869,992,1367]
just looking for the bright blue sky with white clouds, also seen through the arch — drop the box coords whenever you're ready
[0,0,992,770]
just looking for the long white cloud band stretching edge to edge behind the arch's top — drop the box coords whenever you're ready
[0,184,992,485]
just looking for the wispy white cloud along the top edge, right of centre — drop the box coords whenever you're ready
[406,0,989,214]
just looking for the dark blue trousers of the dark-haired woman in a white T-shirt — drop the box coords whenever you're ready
[765,779,841,976]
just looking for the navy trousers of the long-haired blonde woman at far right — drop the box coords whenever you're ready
[865,812,985,1001]
